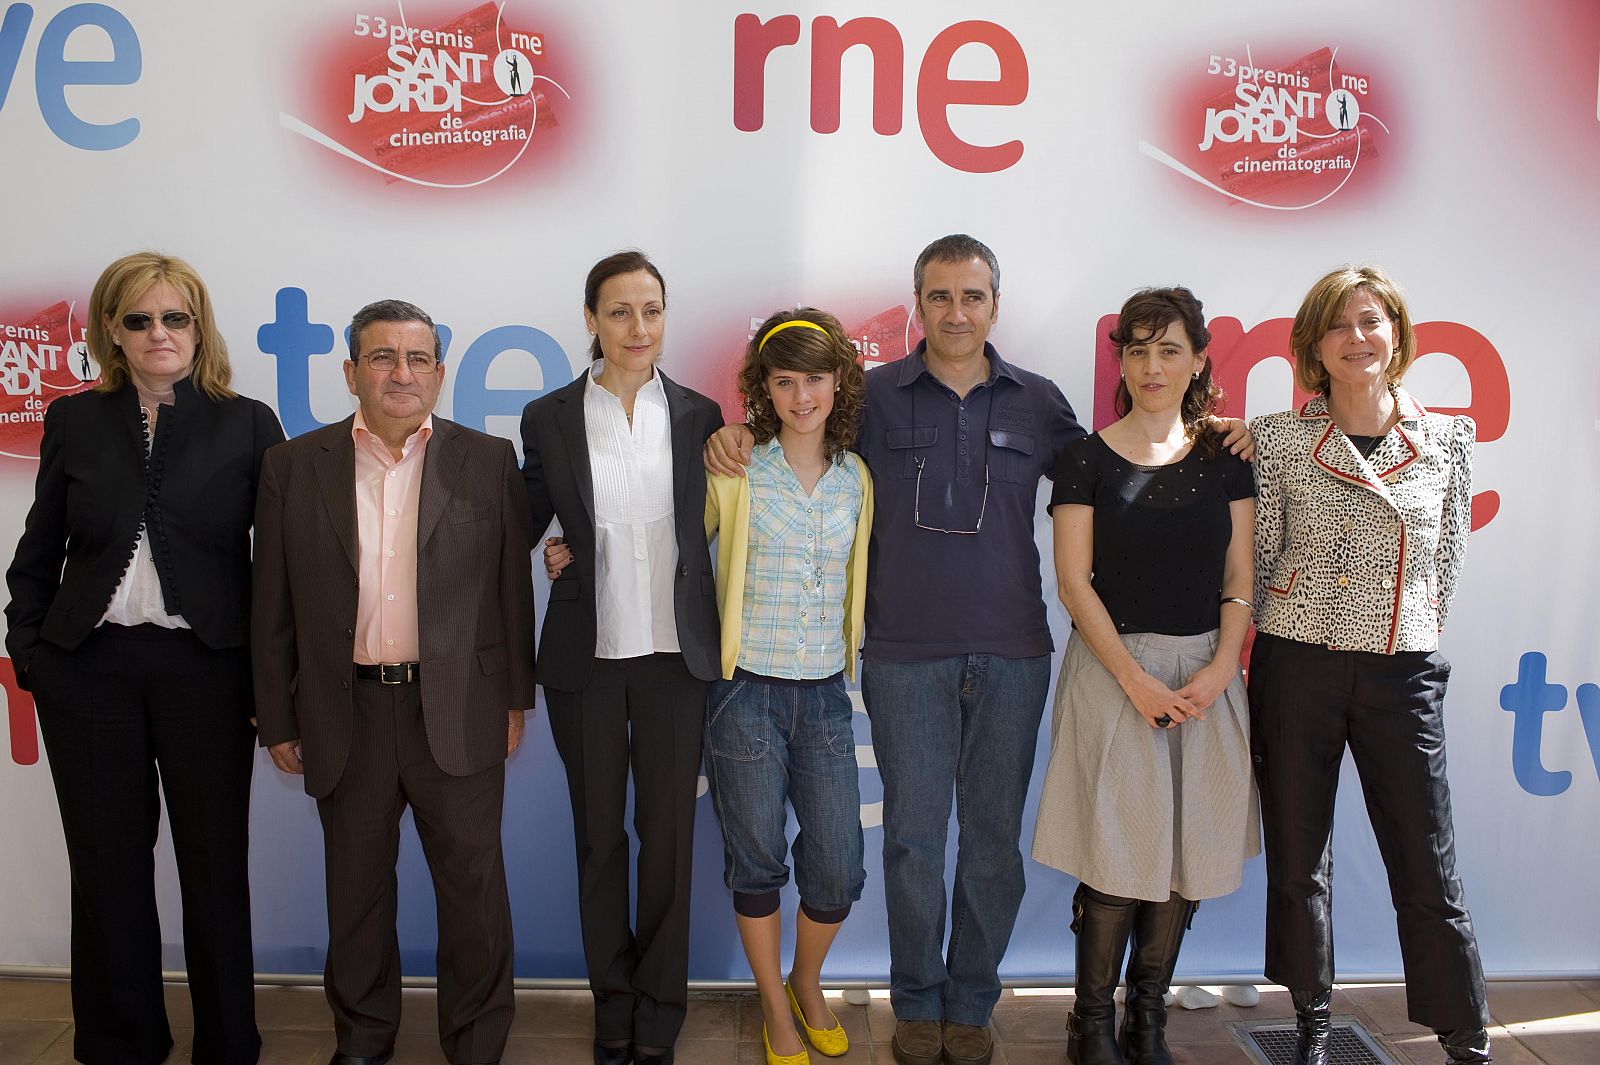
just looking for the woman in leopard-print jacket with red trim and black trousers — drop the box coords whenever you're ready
[1250,265,1490,1065]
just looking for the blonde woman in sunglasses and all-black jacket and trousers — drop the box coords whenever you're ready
[5,253,283,1065]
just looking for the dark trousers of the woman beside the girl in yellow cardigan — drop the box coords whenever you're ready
[544,654,706,1046]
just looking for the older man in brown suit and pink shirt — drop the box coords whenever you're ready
[251,301,534,1065]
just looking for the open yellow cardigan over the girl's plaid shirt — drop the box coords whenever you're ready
[706,451,872,680]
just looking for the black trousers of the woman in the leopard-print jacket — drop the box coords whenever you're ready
[1250,633,1488,1030]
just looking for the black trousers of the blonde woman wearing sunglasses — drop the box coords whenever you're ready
[29,625,261,1065]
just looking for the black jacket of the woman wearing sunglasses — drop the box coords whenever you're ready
[5,377,283,688]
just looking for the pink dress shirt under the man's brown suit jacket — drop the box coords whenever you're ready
[350,409,434,665]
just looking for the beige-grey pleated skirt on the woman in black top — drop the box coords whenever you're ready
[1034,632,1261,902]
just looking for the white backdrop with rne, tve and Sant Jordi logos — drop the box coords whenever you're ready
[0,0,1600,980]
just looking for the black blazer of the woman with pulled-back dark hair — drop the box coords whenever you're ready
[522,371,722,691]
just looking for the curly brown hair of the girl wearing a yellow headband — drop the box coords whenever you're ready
[739,307,867,462]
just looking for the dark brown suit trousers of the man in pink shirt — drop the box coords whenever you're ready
[317,680,515,1062]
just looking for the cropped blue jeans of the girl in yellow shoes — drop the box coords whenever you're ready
[706,678,867,910]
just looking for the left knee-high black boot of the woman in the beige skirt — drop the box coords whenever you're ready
[1067,884,1139,1065]
